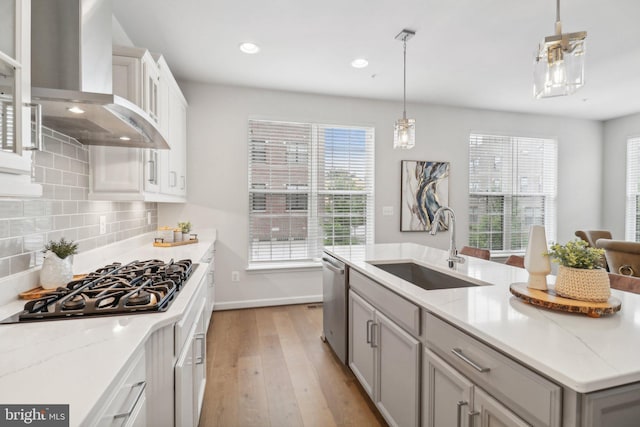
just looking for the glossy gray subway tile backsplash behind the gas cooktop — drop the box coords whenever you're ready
[0,128,158,277]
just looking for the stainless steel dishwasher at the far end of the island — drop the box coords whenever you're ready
[322,252,348,365]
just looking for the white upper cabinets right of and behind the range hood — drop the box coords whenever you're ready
[89,45,187,202]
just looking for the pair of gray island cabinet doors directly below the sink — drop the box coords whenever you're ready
[349,291,421,426]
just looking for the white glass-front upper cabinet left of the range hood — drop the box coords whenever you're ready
[0,0,42,197]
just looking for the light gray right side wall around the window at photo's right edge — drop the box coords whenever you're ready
[602,113,640,240]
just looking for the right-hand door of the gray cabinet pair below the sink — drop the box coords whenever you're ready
[372,311,420,426]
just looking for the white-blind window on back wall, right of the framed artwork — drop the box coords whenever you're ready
[469,134,558,253]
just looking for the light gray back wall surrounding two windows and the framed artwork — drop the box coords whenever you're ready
[159,82,602,308]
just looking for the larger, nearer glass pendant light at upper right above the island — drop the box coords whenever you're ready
[533,0,587,98]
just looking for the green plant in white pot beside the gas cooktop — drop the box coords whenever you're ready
[40,237,78,289]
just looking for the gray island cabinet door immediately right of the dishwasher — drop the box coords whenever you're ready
[349,291,375,399]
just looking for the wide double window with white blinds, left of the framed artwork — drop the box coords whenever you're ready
[247,119,375,270]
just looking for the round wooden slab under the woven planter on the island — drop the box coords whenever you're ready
[509,283,622,317]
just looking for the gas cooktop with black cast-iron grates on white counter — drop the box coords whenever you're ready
[0,259,198,323]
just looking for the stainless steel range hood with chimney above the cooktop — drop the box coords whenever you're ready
[31,0,169,149]
